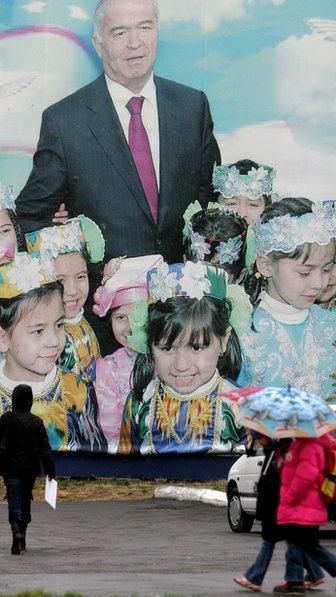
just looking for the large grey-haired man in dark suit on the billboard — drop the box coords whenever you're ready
[17,0,220,262]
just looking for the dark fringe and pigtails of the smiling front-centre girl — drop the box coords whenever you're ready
[132,296,241,401]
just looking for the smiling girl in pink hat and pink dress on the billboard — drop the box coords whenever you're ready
[91,255,163,453]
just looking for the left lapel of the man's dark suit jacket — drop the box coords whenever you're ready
[87,75,153,222]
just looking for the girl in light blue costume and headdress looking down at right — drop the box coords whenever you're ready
[238,197,336,399]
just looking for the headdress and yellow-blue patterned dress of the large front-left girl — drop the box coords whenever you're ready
[0,253,106,451]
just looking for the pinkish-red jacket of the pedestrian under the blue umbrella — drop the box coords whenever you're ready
[277,434,336,526]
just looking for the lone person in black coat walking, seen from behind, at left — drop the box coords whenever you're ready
[0,384,55,555]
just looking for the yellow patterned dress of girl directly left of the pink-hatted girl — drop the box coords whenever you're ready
[59,309,100,375]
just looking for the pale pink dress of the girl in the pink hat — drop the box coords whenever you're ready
[94,348,137,453]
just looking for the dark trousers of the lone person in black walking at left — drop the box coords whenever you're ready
[4,476,36,524]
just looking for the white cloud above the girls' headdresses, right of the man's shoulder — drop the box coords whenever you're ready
[217,121,336,200]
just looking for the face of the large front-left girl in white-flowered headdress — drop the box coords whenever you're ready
[0,291,65,382]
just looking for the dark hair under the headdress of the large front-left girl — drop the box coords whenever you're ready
[0,282,63,334]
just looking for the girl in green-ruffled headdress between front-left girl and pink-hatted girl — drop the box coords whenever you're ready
[26,215,105,375]
